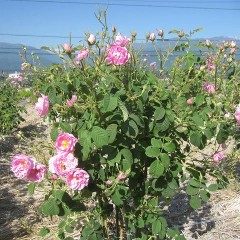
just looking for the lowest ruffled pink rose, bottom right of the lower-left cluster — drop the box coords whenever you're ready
[66,168,89,190]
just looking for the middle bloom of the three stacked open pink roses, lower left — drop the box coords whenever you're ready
[49,153,78,177]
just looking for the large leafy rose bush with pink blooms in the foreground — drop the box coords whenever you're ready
[12,11,240,240]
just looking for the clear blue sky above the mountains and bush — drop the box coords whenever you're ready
[0,0,240,47]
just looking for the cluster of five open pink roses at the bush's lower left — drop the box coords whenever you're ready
[11,133,89,190]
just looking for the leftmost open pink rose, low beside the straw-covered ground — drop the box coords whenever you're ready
[11,154,34,179]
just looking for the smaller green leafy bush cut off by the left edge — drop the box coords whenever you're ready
[0,81,24,135]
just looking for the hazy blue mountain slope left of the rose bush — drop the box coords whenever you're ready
[0,42,61,73]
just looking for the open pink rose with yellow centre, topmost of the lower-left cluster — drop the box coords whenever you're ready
[55,133,78,153]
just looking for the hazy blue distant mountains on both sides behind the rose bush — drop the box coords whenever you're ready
[0,36,240,74]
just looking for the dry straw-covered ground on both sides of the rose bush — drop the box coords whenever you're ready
[0,103,240,240]
